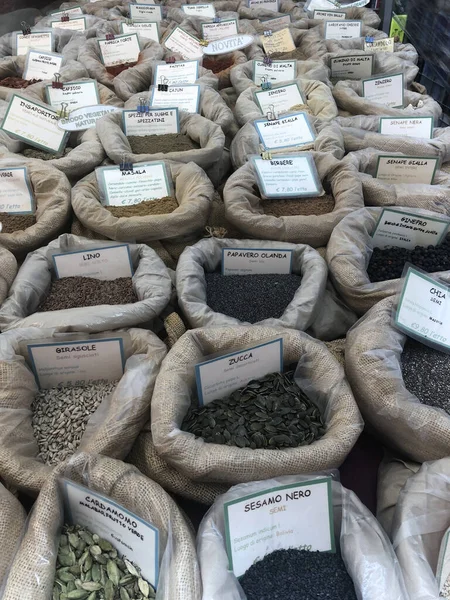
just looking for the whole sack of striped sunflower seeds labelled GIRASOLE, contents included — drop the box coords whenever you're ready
[0,327,166,494]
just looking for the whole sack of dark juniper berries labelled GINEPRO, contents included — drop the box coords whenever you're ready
[326,206,450,315]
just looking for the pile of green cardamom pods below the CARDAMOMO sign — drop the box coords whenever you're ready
[53,525,156,600]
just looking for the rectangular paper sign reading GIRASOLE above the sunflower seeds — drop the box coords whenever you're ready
[27,338,125,389]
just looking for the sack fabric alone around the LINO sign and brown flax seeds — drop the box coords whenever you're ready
[0,234,172,332]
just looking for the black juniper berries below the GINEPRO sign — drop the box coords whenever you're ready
[367,236,450,283]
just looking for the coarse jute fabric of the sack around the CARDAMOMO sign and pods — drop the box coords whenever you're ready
[2,452,201,600]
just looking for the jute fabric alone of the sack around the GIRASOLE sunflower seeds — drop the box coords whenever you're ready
[0,327,166,494]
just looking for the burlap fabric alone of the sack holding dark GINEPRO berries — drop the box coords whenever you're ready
[327,206,447,315]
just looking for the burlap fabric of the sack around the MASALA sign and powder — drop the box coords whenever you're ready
[72,161,214,243]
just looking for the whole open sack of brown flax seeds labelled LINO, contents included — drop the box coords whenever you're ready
[0,234,172,332]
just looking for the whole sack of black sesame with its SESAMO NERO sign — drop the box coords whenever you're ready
[197,471,408,600]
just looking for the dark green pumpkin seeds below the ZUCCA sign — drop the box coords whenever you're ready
[181,371,325,450]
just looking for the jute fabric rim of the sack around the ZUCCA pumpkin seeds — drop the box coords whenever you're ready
[151,325,362,484]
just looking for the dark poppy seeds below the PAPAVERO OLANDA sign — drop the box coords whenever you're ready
[205,273,302,323]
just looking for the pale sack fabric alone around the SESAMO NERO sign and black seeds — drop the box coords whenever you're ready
[197,472,407,600]
